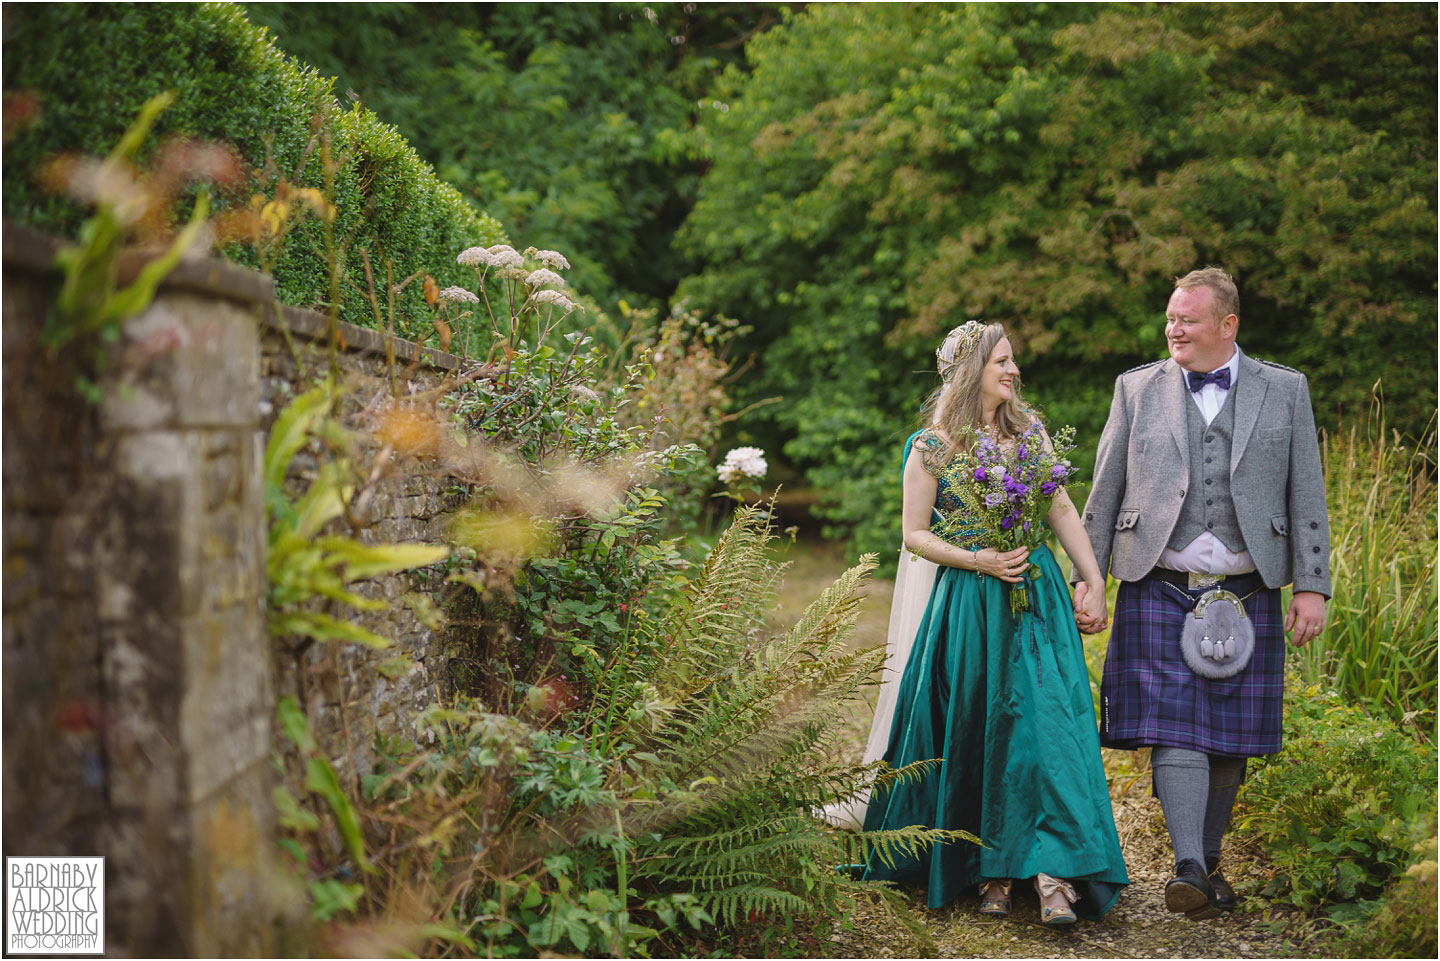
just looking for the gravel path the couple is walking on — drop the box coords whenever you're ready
[778,543,1313,958]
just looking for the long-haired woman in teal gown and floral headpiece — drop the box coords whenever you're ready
[825,321,1129,925]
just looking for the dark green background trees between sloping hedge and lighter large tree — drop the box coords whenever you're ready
[246,3,779,307]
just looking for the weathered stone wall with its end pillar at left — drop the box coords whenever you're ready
[3,225,469,957]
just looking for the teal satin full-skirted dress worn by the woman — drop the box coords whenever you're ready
[863,434,1129,919]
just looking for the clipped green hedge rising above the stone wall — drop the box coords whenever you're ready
[3,3,505,339]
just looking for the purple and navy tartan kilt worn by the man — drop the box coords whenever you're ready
[1100,578,1284,758]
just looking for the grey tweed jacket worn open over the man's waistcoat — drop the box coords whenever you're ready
[1083,353,1331,596]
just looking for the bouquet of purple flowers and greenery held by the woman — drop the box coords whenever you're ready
[935,421,1076,615]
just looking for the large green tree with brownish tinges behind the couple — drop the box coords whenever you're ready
[677,4,1436,549]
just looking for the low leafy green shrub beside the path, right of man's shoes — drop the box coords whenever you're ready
[1237,683,1436,927]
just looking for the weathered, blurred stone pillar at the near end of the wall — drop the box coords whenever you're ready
[95,264,279,955]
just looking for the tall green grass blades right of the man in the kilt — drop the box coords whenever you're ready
[1292,395,1437,741]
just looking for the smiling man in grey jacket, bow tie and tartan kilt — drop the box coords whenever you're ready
[1076,267,1331,919]
